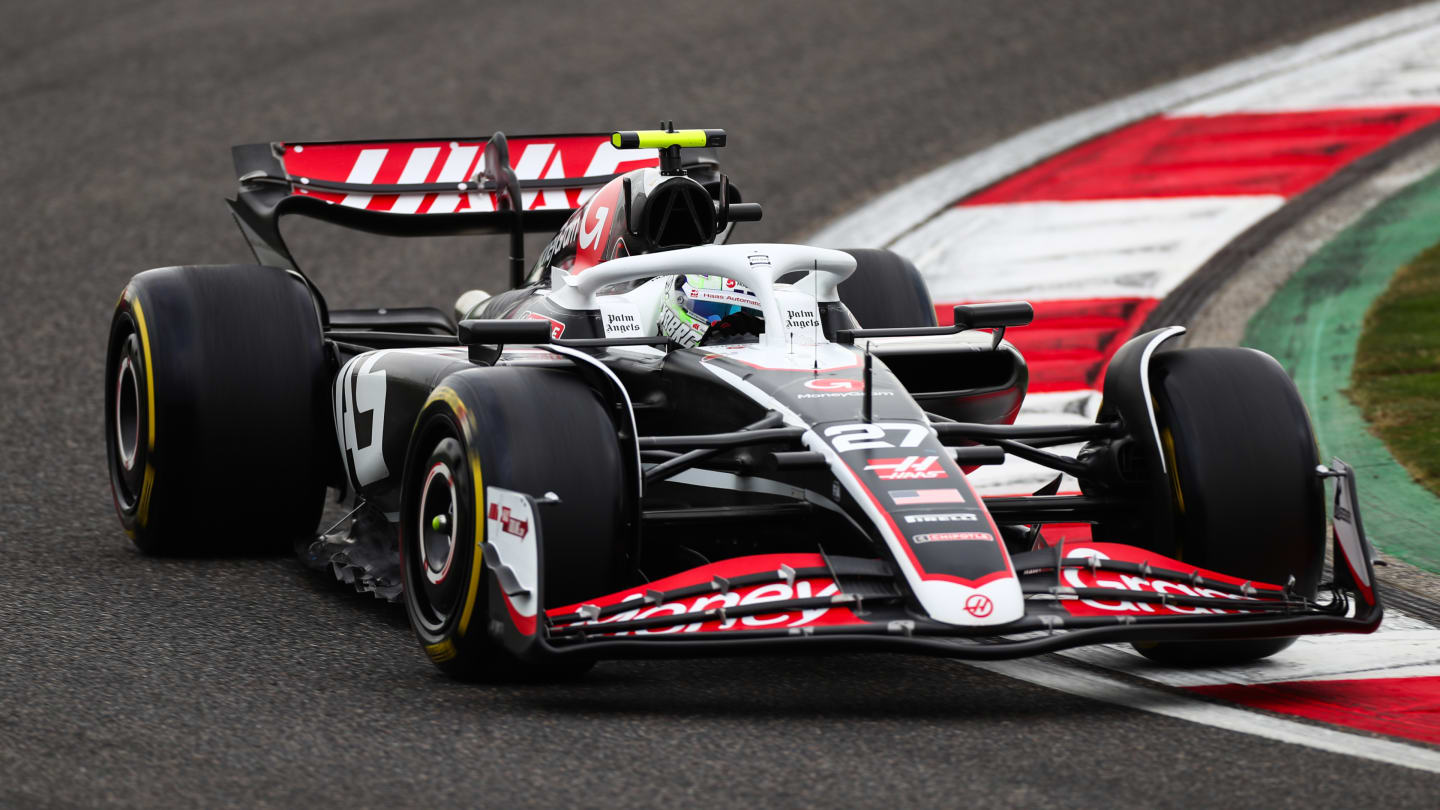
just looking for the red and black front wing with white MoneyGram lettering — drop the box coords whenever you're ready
[484,460,1382,659]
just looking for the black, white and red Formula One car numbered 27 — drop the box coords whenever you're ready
[105,127,1381,677]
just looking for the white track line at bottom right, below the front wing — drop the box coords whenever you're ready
[968,659,1440,774]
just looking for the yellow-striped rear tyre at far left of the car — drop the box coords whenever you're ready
[105,265,333,555]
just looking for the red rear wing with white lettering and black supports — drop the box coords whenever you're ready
[228,133,676,278]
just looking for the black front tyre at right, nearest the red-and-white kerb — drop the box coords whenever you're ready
[1136,349,1325,666]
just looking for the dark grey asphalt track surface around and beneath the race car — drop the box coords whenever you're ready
[0,0,1440,807]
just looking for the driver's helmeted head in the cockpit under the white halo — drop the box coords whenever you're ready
[660,275,765,346]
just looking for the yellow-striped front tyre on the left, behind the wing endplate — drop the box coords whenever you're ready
[400,368,635,682]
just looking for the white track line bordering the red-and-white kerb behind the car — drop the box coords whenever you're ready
[809,1,1440,248]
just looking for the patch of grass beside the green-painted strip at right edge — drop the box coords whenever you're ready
[1346,239,1440,494]
